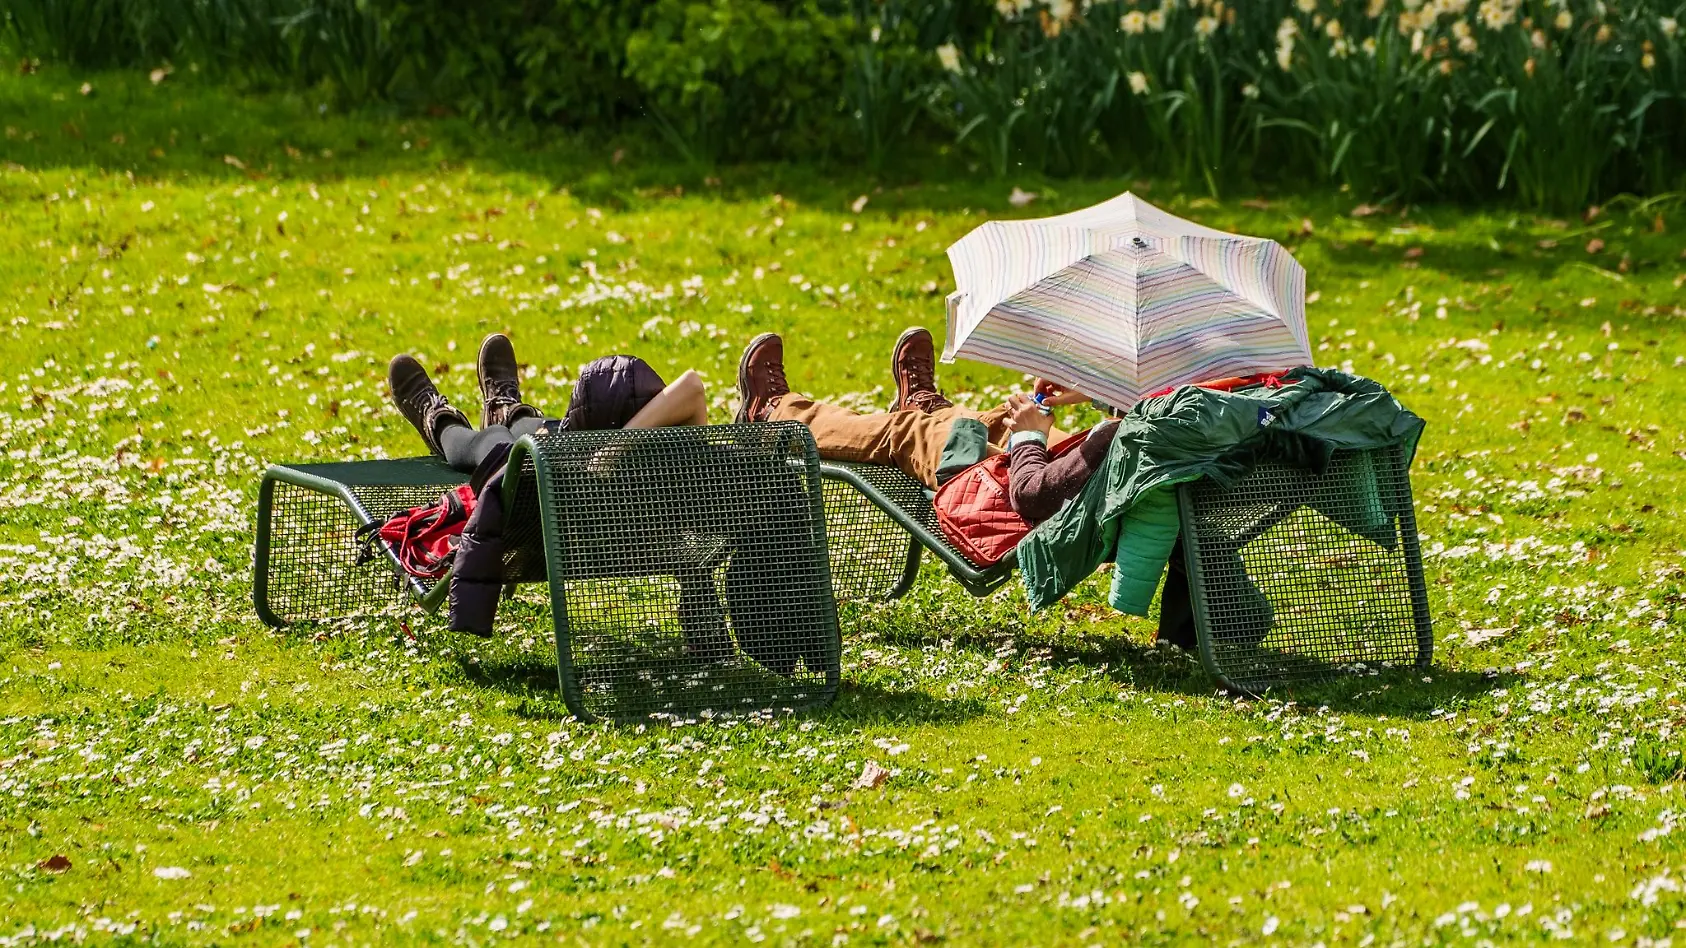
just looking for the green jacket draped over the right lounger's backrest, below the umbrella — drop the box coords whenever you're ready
[1018,360,1423,616]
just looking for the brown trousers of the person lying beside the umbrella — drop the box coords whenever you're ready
[769,393,1008,491]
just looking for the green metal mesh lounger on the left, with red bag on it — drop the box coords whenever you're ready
[255,423,841,720]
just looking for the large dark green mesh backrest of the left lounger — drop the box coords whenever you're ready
[506,423,841,720]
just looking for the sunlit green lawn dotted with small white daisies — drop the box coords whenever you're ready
[0,71,1686,945]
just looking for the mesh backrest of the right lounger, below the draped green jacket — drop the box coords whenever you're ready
[1179,445,1433,692]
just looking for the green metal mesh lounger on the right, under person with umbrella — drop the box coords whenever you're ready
[819,447,1433,692]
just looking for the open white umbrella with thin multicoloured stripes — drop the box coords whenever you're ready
[942,192,1312,407]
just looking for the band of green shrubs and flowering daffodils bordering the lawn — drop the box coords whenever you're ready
[0,0,1686,204]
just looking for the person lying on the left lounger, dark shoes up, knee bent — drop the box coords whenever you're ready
[386,332,708,474]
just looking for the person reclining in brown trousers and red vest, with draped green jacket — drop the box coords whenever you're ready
[738,329,1423,646]
